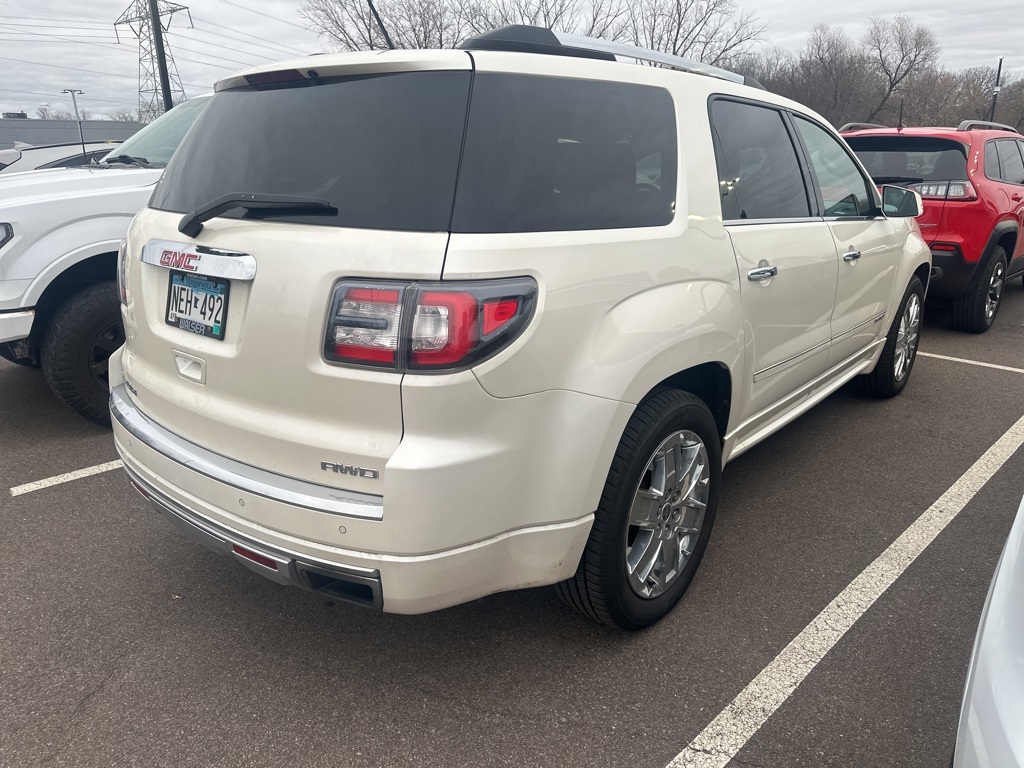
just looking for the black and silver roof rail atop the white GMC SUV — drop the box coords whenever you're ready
[458,25,764,90]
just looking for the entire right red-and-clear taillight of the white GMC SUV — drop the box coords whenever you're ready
[324,278,537,371]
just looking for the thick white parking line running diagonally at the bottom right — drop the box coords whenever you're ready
[669,417,1024,768]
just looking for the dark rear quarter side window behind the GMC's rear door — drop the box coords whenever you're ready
[452,74,676,232]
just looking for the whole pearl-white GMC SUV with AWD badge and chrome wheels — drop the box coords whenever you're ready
[110,27,931,630]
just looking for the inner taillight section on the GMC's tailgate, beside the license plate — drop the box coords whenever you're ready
[324,283,402,367]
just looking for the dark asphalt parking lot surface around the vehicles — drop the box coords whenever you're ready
[0,280,1024,768]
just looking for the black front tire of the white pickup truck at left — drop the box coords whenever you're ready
[42,282,124,424]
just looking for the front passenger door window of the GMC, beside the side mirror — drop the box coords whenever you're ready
[794,117,876,216]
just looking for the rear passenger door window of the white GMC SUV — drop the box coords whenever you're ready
[712,100,811,219]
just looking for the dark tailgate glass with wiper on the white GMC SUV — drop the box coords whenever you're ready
[149,72,470,231]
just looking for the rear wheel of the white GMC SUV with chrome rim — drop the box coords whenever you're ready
[555,389,722,630]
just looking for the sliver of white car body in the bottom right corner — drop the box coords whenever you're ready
[953,502,1024,768]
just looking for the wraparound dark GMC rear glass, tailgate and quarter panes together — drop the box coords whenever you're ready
[151,72,676,232]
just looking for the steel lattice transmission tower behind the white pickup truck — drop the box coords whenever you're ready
[114,0,191,123]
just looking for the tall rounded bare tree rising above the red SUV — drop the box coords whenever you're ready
[864,15,939,122]
